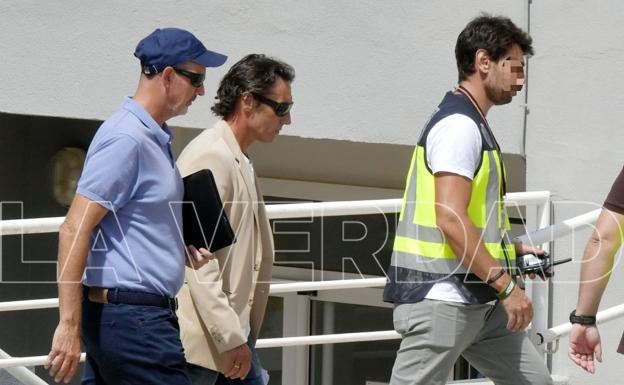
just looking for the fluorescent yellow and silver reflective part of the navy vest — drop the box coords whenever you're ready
[391,133,515,274]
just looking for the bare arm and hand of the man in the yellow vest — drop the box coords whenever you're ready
[435,172,533,331]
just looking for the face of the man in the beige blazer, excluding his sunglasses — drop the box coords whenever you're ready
[249,78,292,143]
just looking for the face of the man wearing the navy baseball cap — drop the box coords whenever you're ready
[168,62,206,117]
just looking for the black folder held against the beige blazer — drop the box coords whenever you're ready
[182,169,236,252]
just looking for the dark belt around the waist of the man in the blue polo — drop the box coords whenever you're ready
[86,287,178,311]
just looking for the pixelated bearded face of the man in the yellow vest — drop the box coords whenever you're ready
[484,44,524,105]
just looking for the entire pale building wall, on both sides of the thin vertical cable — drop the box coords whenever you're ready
[0,0,624,384]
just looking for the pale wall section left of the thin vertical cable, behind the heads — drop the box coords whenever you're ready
[0,0,527,153]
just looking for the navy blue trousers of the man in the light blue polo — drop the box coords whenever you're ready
[82,299,190,385]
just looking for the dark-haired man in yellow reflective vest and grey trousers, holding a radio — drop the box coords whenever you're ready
[384,15,552,385]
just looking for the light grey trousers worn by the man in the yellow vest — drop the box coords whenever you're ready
[390,299,553,385]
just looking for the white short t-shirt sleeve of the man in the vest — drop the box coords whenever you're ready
[427,114,482,180]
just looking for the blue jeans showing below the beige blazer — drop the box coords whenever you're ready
[186,337,264,385]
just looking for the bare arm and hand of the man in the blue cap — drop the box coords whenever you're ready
[45,194,108,383]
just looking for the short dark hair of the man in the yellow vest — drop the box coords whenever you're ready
[455,14,533,81]
